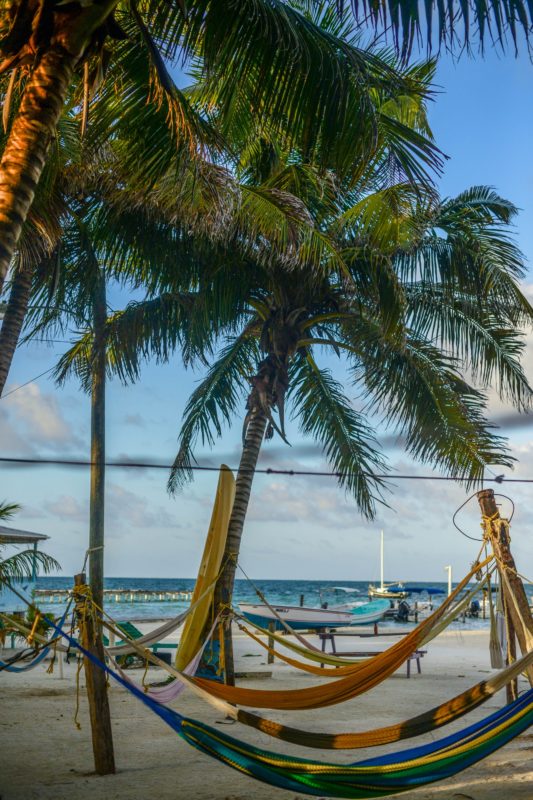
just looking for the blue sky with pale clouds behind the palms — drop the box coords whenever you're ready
[0,52,533,580]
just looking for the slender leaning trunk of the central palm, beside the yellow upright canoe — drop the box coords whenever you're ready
[214,411,267,685]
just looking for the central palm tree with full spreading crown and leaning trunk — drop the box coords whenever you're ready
[98,177,533,679]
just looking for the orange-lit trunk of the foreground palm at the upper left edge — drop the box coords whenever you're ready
[0,45,78,290]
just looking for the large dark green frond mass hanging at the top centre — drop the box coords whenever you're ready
[175,0,440,180]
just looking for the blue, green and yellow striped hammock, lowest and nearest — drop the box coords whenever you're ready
[44,623,533,800]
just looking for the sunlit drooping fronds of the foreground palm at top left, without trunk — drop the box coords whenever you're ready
[0,0,439,182]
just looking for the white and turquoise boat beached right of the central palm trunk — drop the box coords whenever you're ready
[239,600,389,630]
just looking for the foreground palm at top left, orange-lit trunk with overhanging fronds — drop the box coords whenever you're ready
[0,0,446,286]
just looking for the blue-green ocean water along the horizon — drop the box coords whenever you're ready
[37,577,533,629]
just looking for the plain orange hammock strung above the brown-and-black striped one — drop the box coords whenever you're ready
[193,556,486,710]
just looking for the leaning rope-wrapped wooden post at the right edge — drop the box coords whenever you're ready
[477,489,533,686]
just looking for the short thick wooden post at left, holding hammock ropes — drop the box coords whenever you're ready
[74,572,115,775]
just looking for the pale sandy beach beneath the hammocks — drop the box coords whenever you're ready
[0,624,533,800]
